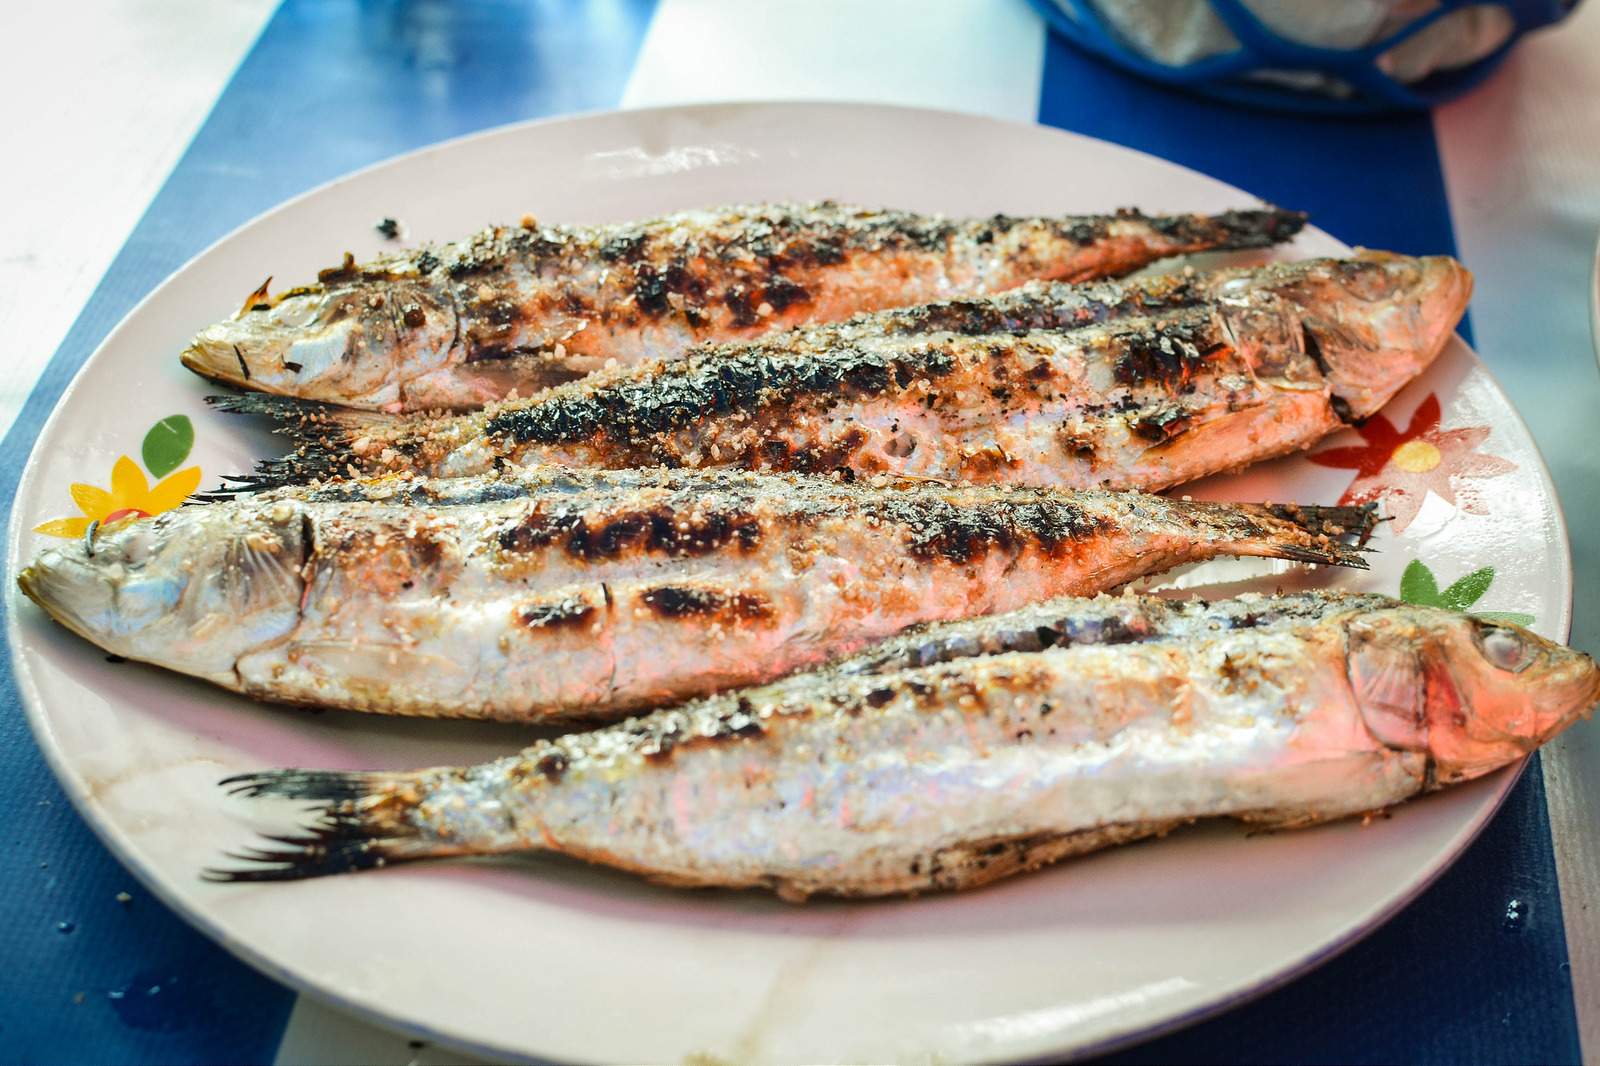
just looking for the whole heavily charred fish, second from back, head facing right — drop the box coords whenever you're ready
[214,251,1472,491]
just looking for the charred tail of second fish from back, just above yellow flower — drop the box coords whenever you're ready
[206,392,406,499]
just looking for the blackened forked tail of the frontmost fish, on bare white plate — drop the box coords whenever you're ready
[202,770,462,882]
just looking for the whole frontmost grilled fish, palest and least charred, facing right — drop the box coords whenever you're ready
[208,594,1600,901]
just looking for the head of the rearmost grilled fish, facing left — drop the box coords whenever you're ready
[182,274,456,408]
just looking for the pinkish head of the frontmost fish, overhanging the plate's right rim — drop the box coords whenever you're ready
[1346,603,1600,784]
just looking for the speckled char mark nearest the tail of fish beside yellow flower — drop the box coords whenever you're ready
[878,498,1107,563]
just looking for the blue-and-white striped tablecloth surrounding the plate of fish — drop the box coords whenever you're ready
[0,0,1600,1063]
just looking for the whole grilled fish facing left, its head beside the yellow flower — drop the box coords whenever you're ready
[18,471,1371,722]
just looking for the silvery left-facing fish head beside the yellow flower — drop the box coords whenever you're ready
[18,503,306,683]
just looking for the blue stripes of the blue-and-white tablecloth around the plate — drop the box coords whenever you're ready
[0,0,1579,1063]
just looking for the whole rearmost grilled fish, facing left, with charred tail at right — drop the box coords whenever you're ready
[182,202,1306,411]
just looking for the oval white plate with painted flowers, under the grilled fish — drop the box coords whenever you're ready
[8,106,1571,1063]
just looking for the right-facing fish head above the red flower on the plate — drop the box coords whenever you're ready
[1219,250,1472,421]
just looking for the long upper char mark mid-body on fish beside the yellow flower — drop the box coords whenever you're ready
[498,507,762,562]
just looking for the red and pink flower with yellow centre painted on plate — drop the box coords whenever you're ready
[1306,392,1517,533]
